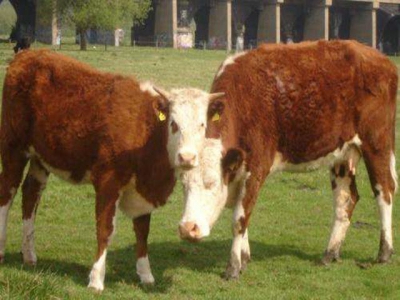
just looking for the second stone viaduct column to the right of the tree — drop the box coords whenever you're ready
[208,0,232,51]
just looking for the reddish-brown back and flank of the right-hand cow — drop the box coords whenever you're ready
[212,41,397,164]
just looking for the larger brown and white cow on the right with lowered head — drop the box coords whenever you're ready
[180,41,397,278]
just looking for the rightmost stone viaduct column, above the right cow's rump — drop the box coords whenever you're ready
[350,1,379,48]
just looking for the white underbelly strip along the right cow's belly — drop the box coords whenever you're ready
[270,134,362,173]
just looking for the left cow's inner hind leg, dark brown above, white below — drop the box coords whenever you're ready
[22,158,49,265]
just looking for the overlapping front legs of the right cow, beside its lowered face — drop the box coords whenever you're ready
[225,175,262,279]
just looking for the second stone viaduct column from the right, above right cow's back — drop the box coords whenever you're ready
[304,0,332,41]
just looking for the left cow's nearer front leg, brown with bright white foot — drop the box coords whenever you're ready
[88,172,121,292]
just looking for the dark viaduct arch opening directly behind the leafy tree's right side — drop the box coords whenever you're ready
[131,1,157,46]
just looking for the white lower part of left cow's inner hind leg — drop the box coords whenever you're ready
[22,213,37,265]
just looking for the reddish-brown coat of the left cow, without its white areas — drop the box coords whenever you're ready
[0,50,175,274]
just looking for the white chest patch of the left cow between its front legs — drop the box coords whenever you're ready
[118,176,155,219]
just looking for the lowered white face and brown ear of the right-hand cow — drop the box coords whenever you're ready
[179,139,244,241]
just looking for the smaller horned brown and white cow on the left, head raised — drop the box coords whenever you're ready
[0,50,225,291]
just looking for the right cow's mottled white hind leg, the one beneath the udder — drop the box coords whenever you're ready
[322,151,360,265]
